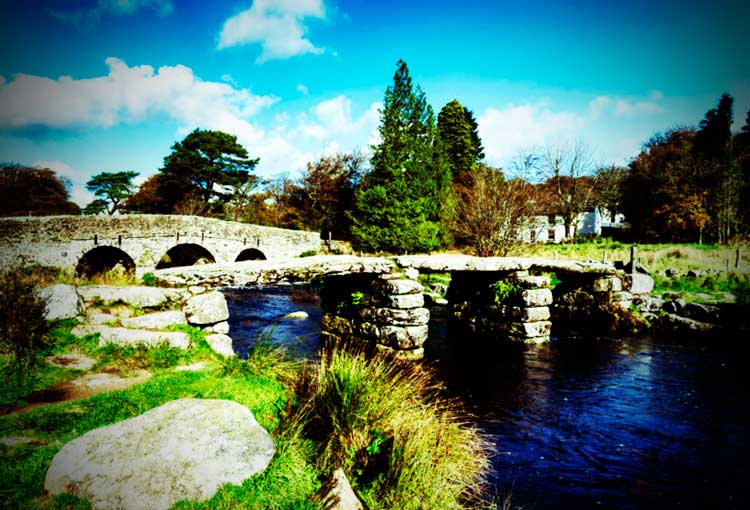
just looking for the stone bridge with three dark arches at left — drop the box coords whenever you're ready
[0,215,325,274]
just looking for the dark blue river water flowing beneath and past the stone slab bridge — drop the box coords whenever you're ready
[227,287,750,509]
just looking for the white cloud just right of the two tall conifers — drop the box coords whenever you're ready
[477,102,588,165]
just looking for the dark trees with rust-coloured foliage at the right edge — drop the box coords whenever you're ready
[622,94,750,243]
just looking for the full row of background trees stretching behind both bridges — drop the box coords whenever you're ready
[5,61,750,251]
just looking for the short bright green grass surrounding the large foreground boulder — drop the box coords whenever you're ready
[0,321,320,510]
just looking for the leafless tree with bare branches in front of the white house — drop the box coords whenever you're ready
[543,142,594,237]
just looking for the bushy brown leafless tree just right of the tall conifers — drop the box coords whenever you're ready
[456,165,534,257]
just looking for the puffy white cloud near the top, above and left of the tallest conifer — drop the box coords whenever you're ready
[218,0,326,63]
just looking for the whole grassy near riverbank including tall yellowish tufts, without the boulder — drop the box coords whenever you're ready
[0,268,489,509]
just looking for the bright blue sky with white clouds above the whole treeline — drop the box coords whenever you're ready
[0,0,750,205]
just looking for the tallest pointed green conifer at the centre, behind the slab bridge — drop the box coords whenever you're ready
[351,60,450,252]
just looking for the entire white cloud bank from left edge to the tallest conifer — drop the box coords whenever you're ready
[0,58,381,189]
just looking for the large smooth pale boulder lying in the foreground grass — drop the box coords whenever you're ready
[44,398,276,510]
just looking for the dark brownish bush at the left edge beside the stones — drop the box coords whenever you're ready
[0,268,49,380]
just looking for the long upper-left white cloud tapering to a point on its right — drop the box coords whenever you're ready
[0,57,278,128]
